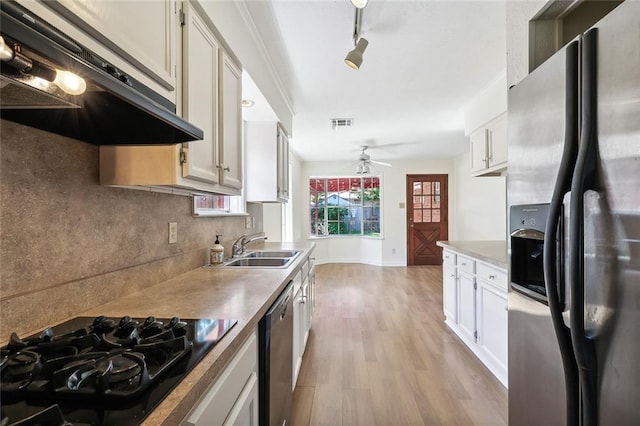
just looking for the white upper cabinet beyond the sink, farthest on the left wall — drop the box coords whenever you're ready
[245,121,289,202]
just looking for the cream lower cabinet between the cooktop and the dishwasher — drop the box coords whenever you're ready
[182,331,258,426]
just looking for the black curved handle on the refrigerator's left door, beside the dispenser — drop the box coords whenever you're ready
[543,41,580,426]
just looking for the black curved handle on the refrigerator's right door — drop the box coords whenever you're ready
[569,28,598,426]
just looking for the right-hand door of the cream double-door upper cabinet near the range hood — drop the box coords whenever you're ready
[220,51,242,189]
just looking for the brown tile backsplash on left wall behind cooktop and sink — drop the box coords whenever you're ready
[0,120,262,342]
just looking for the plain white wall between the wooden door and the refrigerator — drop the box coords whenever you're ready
[451,152,507,241]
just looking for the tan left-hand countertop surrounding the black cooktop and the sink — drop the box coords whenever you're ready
[78,242,314,426]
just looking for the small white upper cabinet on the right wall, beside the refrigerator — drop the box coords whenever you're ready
[470,114,507,176]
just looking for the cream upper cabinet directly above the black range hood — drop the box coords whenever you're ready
[46,0,178,103]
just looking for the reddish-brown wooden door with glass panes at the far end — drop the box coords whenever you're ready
[407,175,449,265]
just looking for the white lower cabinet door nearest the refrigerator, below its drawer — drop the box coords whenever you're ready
[478,281,508,369]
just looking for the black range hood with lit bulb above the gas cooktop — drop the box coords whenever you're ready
[0,0,203,145]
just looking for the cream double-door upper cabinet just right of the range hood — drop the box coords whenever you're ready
[100,2,243,195]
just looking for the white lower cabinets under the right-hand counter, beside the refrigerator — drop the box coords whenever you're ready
[442,249,508,386]
